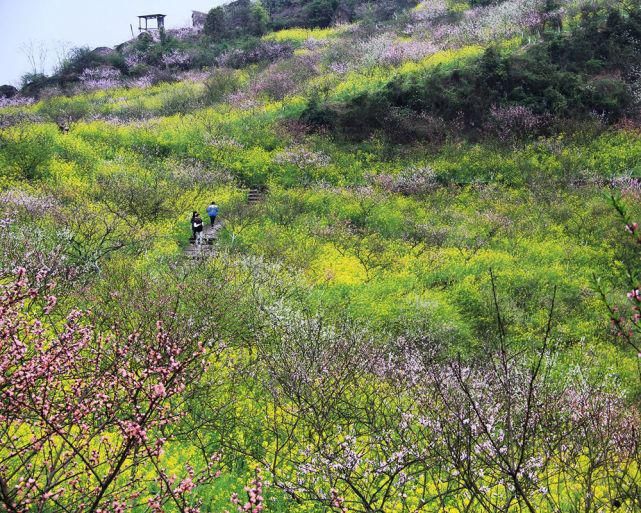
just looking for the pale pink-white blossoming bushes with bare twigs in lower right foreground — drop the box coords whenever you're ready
[236,300,640,513]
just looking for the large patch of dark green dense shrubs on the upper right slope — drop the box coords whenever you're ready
[305,9,641,138]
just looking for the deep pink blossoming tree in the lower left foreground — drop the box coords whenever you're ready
[0,268,216,513]
